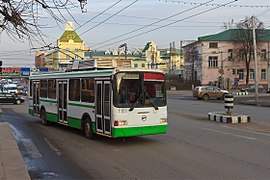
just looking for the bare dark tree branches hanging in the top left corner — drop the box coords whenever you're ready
[0,0,84,43]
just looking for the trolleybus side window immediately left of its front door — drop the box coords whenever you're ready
[81,78,95,103]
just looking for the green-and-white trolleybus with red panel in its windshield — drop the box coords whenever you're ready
[29,68,168,139]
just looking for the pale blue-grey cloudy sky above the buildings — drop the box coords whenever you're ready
[0,0,270,67]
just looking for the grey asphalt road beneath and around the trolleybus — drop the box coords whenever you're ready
[0,95,270,179]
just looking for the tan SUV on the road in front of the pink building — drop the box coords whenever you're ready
[193,86,229,100]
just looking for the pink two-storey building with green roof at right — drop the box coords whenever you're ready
[183,29,270,89]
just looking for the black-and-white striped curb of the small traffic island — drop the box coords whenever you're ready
[208,112,250,124]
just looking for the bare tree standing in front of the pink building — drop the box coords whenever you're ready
[234,17,264,85]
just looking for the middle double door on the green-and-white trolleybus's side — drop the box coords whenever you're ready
[57,80,68,124]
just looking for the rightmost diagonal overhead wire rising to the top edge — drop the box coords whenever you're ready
[94,0,237,48]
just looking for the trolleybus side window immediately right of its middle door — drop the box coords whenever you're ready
[69,79,81,101]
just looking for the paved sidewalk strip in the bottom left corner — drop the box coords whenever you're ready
[0,109,31,180]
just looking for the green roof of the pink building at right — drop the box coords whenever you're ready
[198,29,270,42]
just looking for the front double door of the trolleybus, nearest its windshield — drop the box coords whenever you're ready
[95,80,111,136]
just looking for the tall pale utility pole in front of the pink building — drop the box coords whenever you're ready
[252,16,259,105]
